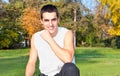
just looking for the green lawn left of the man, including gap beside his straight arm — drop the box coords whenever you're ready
[0,49,39,76]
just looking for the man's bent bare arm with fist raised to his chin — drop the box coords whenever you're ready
[42,31,74,63]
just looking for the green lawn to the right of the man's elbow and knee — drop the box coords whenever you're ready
[76,47,120,76]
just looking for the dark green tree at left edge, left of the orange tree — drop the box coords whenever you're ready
[0,0,23,49]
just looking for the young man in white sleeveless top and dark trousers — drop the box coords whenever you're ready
[26,5,79,76]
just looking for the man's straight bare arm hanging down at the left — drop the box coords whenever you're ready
[25,37,37,76]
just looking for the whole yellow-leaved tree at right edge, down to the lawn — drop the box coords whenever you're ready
[95,0,120,47]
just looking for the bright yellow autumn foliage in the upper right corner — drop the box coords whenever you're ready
[98,0,120,36]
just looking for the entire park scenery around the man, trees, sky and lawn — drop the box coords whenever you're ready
[0,0,120,76]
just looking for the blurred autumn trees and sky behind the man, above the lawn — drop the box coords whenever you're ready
[0,0,120,49]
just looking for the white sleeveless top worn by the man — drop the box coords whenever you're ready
[34,27,74,76]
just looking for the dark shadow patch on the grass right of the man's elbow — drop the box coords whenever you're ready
[75,49,105,63]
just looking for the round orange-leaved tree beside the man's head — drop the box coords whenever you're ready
[21,7,42,37]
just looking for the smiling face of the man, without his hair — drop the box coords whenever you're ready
[41,12,59,35]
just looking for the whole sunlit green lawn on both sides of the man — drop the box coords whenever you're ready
[0,47,120,76]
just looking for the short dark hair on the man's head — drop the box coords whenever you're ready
[40,4,59,19]
